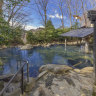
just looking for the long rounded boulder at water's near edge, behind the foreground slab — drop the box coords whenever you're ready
[39,64,73,74]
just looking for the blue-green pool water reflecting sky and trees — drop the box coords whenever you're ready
[0,45,93,77]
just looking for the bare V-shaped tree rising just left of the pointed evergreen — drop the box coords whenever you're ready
[35,0,49,26]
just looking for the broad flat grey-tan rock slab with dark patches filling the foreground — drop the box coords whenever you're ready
[30,71,93,96]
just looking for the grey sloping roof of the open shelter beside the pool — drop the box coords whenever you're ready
[61,28,93,38]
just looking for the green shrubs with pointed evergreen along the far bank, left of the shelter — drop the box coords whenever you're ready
[27,20,70,44]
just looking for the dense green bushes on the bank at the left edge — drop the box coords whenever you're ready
[0,18,22,45]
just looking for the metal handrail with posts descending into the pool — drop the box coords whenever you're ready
[0,61,29,96]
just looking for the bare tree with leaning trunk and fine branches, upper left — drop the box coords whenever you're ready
[4,0,29,26]
